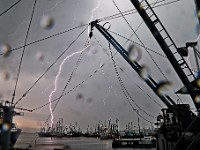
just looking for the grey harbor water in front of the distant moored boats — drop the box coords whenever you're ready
[15,133,155,150]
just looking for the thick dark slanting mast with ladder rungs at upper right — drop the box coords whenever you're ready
[130,0,200,110]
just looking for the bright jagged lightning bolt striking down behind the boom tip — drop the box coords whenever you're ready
[49,0,102,127]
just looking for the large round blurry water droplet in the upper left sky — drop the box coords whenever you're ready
[40,15,54,29]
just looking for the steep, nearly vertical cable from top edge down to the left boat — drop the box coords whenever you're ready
[11,0,37,104]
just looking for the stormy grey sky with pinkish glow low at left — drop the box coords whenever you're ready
[0,0,198,131]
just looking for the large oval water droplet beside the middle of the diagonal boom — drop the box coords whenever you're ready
[127,44,142,61]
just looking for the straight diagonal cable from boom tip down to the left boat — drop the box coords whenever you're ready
[15,26,88,105]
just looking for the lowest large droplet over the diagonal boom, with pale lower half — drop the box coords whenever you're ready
[156,81,171,95]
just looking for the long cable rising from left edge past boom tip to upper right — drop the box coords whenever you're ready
[0,0,180,56]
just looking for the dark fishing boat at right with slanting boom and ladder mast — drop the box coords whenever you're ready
[90,0,200,150]
